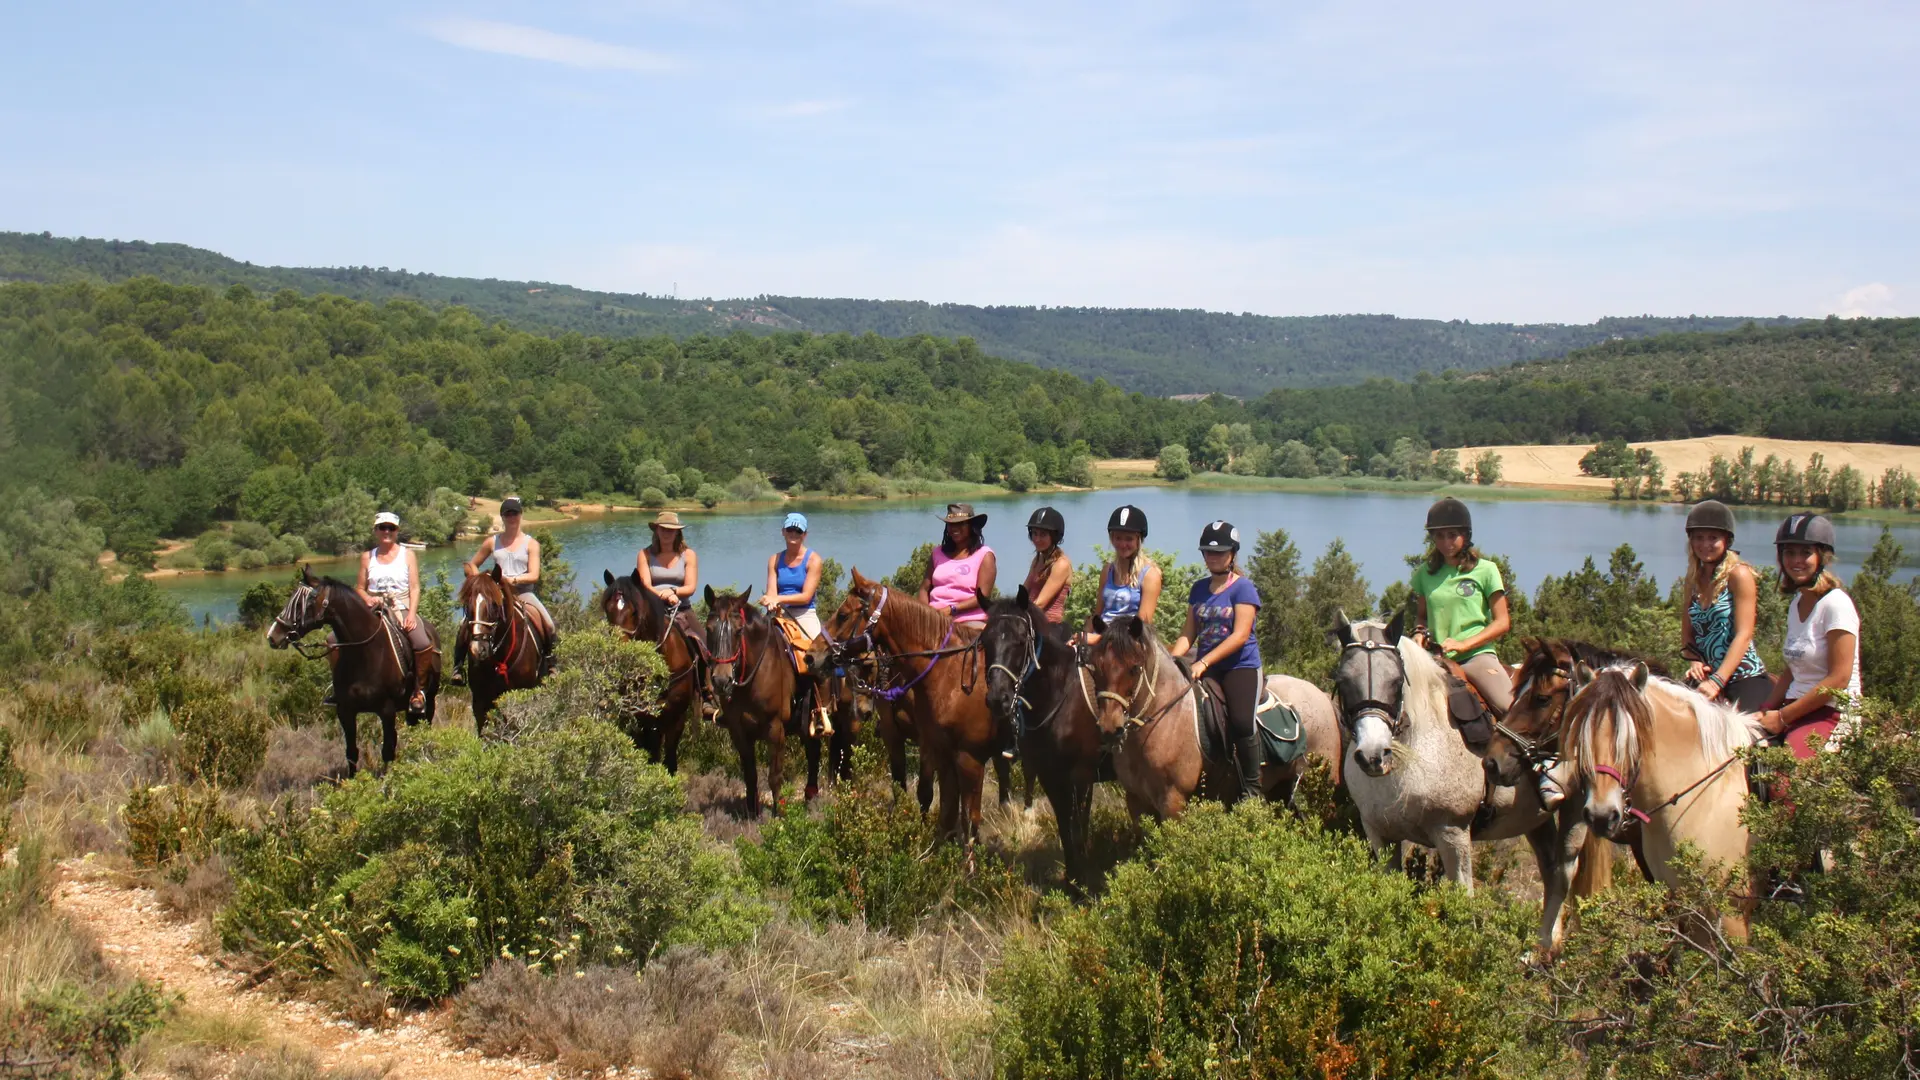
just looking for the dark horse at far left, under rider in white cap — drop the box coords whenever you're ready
[267,567,440,776]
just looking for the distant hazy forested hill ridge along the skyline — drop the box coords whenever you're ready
[0,233,1801,398]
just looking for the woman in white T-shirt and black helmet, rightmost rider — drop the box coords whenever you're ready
[1759,513,1860,757]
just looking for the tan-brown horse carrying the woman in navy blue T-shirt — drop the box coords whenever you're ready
[1087,615,1340,819]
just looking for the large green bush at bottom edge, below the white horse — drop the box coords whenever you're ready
[991,805,1526,1078]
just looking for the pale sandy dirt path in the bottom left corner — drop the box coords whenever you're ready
[54,861,559,1080]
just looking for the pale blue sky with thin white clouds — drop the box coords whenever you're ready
[0,0,1920,321]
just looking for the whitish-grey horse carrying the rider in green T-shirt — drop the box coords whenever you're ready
[1332,613,1613,955]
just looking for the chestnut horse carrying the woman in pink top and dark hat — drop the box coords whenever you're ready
[828,569,1008,842]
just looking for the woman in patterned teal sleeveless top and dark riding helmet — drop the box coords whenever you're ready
[1680,500,1774,713]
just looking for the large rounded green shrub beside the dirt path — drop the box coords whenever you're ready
[219,721,764,999]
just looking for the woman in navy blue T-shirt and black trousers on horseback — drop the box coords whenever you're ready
[1171,521,1260,803]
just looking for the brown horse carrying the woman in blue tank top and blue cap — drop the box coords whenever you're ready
[707,586,837,817]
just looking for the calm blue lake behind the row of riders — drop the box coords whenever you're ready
[161,488,1920,623]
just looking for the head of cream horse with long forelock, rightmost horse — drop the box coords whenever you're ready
[1561,661,1653,840]
